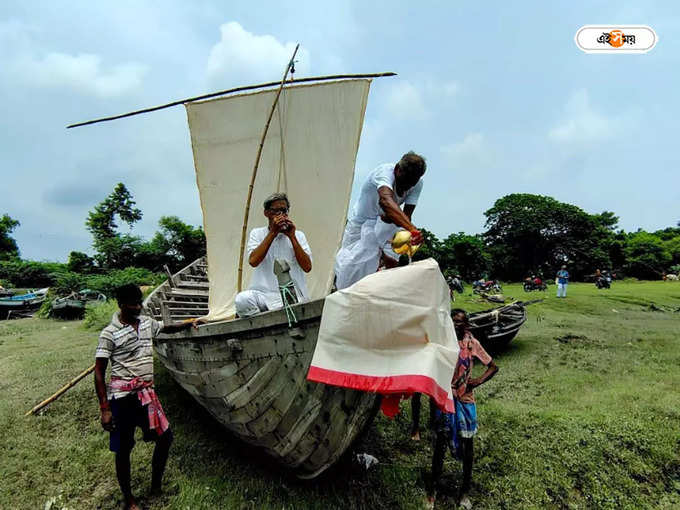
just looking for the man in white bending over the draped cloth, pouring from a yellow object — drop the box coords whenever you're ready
[335,151,426,289]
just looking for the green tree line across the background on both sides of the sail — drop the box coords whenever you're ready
[0,183,680,293]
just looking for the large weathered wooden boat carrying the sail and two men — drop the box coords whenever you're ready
[145,259,379,478]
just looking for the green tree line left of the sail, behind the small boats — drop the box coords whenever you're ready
[0,183,206,296]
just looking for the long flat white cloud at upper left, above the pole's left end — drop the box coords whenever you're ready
[15,53,146,97]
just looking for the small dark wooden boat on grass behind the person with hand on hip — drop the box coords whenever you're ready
[468,300,540,350]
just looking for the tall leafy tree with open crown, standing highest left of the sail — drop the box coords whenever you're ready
[85,182,142,269]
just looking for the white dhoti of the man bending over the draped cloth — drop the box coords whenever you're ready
[335,218,399,289]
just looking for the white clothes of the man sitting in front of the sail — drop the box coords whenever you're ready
[236,227,312,315]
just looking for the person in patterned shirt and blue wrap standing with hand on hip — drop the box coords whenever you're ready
[427,308,498,508]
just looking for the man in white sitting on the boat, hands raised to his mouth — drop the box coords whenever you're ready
[235,193,312,317]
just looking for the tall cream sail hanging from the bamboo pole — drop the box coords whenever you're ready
[186,79,371,320]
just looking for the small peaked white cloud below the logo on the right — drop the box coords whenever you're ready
[548,89,621,143]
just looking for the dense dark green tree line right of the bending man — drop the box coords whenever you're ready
[415,193,680,281]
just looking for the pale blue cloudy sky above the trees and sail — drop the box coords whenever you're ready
[0,0,680,261]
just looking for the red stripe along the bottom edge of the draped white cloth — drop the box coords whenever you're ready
[307,366,454,413]
